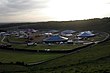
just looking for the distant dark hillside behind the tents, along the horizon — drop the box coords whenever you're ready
[0,18,110,31]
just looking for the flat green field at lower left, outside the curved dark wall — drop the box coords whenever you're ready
[0,50,63,63]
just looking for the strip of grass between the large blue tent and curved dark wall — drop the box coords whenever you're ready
[12,44,82,50]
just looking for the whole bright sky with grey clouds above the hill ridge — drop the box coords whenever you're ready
[0,0,110,22]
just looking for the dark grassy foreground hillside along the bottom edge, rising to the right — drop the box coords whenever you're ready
[0,36,110,73]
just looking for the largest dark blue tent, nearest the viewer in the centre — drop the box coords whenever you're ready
[43,35,68,43]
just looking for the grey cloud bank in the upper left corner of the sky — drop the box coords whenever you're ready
[0,0,48,15]
